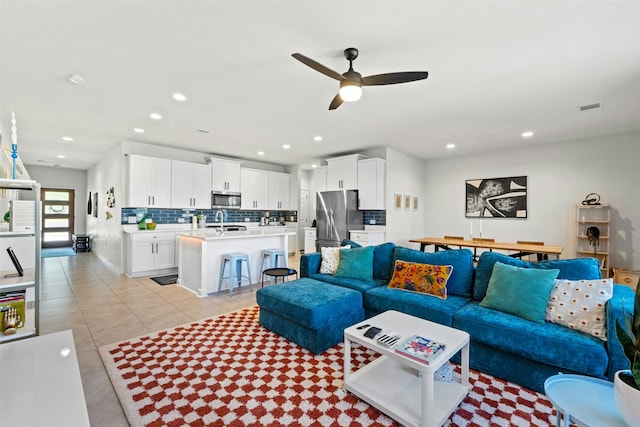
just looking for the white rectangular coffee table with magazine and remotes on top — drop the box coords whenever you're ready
[344,311,471,427]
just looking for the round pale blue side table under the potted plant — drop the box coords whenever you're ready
[544,374,626,427]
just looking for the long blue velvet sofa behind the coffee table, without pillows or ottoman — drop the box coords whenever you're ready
[290,241,634,392]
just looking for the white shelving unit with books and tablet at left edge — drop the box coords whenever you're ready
[0,179,42,343]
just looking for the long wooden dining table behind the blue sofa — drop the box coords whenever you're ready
[409,237,564,260]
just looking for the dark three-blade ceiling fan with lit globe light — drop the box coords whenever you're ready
[291,47,429,110]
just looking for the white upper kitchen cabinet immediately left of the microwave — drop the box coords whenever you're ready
[171,160,211,209]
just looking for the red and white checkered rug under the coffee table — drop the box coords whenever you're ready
[100,306,555,427]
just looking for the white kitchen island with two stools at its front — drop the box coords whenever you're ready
[177,226,295,298]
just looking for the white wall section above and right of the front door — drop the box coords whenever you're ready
[26,165,89,233]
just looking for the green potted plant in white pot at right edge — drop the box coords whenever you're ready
[613,281,640,425]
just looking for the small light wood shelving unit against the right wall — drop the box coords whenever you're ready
[576,204,611,278]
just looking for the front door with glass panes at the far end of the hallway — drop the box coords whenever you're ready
[41,188,75,248]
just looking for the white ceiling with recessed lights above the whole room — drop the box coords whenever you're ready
[0,0,640,169]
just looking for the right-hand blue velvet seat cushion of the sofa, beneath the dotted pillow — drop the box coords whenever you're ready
[453,301,608,377]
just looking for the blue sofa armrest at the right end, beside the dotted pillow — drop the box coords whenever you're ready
[606,284,635,381]
